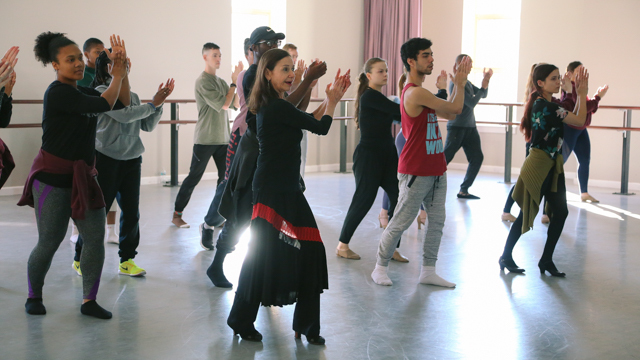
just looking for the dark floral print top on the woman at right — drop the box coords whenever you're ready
[531,98,569,159]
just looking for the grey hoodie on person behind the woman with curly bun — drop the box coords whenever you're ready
[96,85,162,160]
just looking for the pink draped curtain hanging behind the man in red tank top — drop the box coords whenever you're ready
[363,0,422,96]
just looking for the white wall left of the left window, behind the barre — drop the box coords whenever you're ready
[0,0,231,191]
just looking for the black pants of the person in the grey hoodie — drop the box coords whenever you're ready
[74,152,142,261]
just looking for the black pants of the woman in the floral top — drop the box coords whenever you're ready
[502,169,569,262]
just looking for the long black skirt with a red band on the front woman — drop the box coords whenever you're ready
[237,191,329,306]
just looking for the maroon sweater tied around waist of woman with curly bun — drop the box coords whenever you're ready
[18,149,105,220]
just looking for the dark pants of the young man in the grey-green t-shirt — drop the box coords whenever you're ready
[175,144,227,216]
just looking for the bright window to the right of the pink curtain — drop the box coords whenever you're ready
[462,0,521,121]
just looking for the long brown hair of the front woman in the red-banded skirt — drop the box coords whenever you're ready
[247,49,291,114]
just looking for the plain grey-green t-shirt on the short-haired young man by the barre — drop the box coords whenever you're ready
[193,71,238,145]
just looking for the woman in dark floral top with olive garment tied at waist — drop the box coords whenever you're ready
[500,64,589,277]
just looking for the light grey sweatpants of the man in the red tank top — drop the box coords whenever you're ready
[377,173,447,266]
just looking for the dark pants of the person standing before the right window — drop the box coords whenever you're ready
[444,126,484,193]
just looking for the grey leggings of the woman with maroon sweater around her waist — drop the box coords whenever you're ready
[28,180,106,300]
